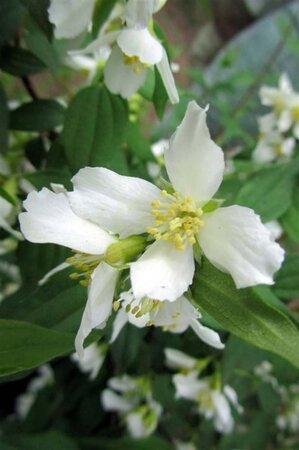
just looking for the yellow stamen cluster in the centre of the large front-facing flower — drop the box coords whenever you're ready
[146,191,203,250]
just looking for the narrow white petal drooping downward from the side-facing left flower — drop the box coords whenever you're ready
[75,262,118,358]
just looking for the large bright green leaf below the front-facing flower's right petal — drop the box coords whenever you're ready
[193,258,299,368]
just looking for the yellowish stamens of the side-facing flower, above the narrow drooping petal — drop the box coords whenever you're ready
[65,253,102,286]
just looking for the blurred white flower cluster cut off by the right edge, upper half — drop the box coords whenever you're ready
[253,73,299,163]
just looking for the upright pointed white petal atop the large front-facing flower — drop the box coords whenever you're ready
[165,101,224,203]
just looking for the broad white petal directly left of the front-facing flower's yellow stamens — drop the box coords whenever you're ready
[69,167,160,237]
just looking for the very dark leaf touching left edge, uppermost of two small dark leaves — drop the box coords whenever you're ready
[0,45,46,77]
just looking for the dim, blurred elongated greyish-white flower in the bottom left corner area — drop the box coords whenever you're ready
[15,365,54,419]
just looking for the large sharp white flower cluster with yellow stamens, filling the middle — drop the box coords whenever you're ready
[19,102,284,357]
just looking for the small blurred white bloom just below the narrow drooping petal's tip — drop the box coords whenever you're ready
[71,343,106,380]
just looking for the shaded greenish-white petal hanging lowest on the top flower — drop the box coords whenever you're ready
[104,45,147,99]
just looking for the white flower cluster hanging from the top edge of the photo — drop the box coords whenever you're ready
[49,0,179,103]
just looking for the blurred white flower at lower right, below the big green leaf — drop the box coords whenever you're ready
[173,371,242,433]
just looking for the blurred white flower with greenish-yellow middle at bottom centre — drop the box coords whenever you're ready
[101,375,162,438]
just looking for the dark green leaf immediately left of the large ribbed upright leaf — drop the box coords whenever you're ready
[10,100,64,132]
